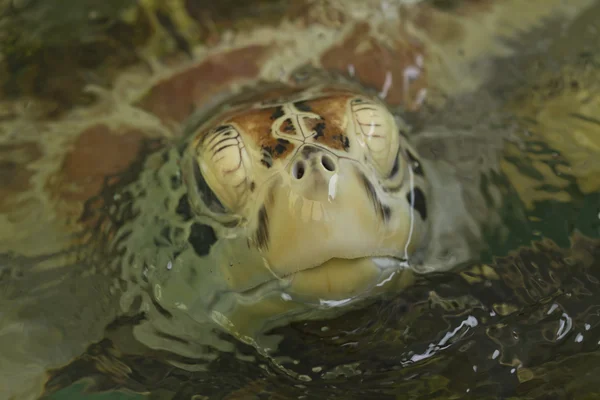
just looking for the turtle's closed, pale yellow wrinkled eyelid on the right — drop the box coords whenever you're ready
[351,98,400,176]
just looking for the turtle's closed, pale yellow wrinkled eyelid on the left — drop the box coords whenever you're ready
[194,125,251,213]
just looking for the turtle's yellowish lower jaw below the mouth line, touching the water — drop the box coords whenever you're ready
[211,257,415,344]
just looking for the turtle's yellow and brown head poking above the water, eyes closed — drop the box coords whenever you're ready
[184,88,428,299]
